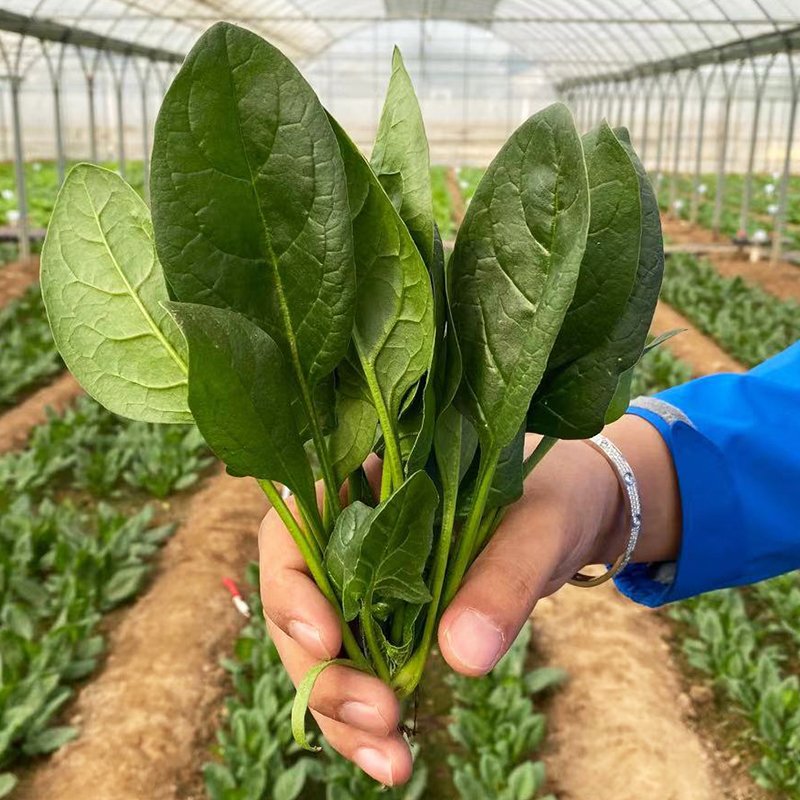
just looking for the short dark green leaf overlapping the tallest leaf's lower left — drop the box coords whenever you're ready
[168,302,316,508]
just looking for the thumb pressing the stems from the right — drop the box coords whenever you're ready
[439,508,561,676]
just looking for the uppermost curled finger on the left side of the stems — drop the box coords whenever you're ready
[258,506,342,661]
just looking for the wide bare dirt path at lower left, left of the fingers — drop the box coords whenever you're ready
[14,473,267,800]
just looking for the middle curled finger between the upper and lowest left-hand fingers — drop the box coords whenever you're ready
[267,621,400,749]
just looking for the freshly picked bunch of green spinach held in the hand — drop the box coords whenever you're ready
[41,23,663,743]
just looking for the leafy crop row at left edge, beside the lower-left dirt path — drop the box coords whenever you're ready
[0,398,210,796]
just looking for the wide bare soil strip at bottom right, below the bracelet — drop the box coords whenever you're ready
[533,585,733,800]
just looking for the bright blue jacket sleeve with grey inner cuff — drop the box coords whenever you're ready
[617,342,800,606]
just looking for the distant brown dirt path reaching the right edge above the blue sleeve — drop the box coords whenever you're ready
[663,216,800,302]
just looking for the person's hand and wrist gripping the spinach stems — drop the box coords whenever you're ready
[259,417,680,785]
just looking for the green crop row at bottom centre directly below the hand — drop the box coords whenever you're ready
[204,565,564,800]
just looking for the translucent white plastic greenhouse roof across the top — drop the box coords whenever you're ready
[0,0,800,83]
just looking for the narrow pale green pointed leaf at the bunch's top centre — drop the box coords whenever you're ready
[371,47,433,264]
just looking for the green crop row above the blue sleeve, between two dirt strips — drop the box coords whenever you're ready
[661,253,800,367]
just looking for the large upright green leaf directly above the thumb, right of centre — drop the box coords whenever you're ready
[450,104,589,453]
